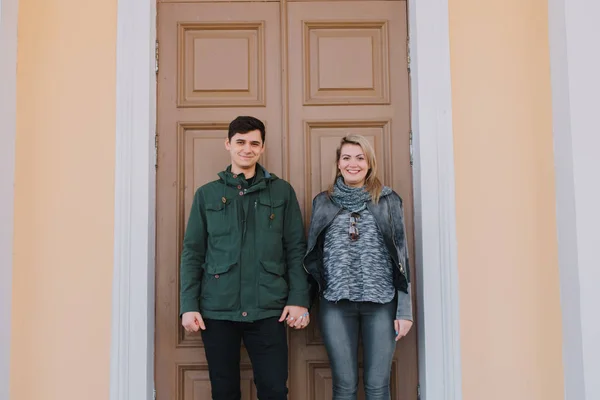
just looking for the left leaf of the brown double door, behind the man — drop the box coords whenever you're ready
[155,3,282,400]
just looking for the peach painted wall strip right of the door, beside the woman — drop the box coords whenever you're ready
[449,0,564,400]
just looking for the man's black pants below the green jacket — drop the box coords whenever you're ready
[202,317,288,400]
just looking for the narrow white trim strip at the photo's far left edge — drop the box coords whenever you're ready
[0,0,19,399]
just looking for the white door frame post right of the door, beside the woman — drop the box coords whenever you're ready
[408,0,462,400]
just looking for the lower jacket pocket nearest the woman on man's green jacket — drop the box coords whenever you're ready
[258,261,289,310]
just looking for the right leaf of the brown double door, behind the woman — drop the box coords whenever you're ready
[288,1,417,399]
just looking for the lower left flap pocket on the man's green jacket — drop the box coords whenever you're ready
[200,263,240,311]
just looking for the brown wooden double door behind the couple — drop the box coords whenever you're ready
[155,0,417,400]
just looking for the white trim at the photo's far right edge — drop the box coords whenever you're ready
[548,0,600,400]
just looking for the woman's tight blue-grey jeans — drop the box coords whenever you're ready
[320,298,396,400]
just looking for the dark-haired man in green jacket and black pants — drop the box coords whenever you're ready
[180,117,310,400]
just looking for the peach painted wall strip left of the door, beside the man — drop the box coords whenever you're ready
[10,0,116,400]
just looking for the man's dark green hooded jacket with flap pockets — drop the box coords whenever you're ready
[180,165,309,322]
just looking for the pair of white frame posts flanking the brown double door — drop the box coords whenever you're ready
[110,0,462,400]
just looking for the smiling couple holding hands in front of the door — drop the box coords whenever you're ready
[180,117,412,400]
